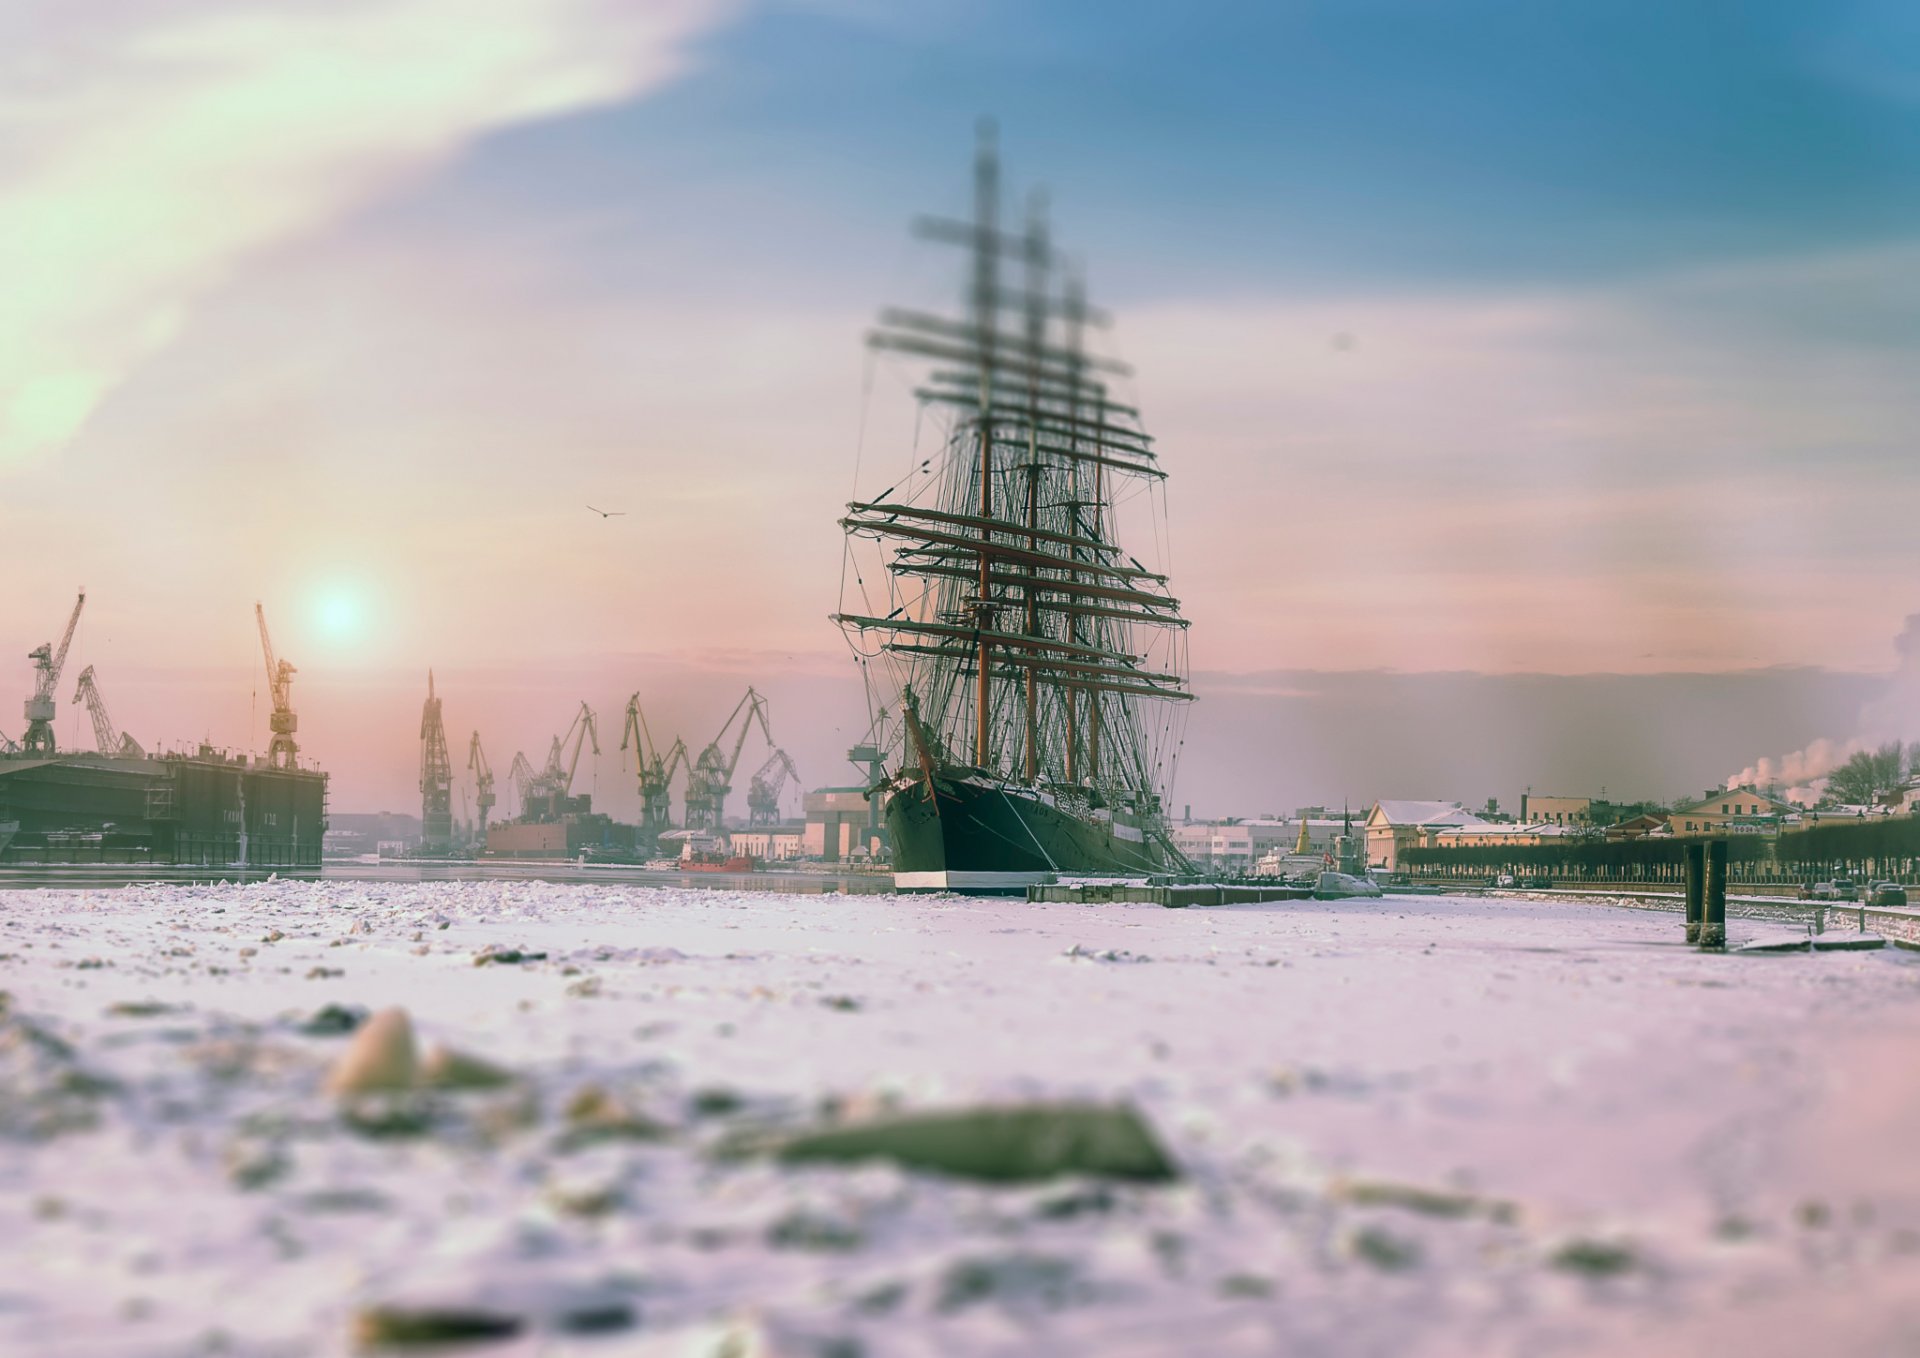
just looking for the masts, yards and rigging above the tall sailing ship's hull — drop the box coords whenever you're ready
[833,129,1192,805]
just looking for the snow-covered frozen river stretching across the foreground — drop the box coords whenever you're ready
[0,882,1920,1358]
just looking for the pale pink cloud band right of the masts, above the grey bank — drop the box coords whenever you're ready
[1119,244,1920,672]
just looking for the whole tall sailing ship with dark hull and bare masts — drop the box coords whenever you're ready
[833,129,1192,893]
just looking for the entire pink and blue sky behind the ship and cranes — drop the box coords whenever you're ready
[0,0,1920,812]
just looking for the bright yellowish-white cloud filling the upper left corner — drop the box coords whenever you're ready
[0,0,724,473]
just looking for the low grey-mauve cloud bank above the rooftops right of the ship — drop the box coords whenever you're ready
[1173,668,1885,814]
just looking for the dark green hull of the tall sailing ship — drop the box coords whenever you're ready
[883,778,1169,895]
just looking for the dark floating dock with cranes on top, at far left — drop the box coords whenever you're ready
[0,590,326,870]
